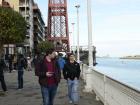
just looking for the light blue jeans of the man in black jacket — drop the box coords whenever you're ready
[68,80,79,104]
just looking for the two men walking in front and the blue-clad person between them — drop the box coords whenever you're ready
[35,49,81,105]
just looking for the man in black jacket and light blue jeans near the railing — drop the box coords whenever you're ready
[63,54,81,105]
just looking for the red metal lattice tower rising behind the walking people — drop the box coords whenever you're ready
[47,0,70,52]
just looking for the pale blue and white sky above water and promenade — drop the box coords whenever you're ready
[35,0,140,56]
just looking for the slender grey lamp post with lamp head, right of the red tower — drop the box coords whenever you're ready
[75,5,80,63]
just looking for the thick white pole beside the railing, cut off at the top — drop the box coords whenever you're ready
[87,0,93,67]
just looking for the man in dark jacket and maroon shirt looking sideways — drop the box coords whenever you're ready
[35,49,61,105]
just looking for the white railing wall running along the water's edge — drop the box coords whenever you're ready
[82,64,140,105]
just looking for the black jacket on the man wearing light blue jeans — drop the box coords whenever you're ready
[63,61,81,80]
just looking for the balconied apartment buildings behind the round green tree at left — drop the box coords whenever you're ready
[2,0,45,56]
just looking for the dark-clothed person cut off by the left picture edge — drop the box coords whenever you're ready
[0,59,7,92]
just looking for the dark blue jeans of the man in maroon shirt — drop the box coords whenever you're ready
[41,85,58,105]
